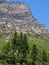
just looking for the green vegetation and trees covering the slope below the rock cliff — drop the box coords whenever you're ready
[0,31,49,65]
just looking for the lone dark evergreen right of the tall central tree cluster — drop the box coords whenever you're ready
[31,44,38,65]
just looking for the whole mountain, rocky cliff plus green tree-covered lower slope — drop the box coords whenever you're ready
[0,2,49,65]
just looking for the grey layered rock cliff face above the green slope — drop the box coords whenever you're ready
[0,2,49,37]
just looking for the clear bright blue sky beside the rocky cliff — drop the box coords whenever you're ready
[7,0,49,29]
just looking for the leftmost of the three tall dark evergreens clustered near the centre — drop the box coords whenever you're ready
[11,31,18,53]
